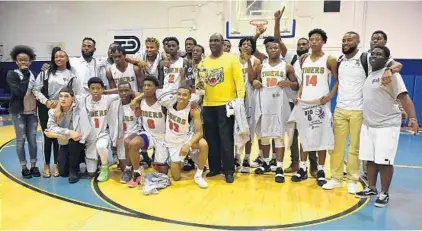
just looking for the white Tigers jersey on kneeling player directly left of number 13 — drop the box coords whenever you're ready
[141,99,166,140]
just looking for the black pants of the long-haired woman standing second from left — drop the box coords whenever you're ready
[38,104,59,165]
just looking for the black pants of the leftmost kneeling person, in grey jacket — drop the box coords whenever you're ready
[58,140,85,177]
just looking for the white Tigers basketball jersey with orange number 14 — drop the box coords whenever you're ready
[301,54,331,100]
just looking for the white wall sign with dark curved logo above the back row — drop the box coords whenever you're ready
[108,30,142,55]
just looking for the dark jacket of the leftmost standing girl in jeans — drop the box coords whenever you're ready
[7,70,37,114]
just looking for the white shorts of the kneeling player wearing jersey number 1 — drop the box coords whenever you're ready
[85,134,110,173]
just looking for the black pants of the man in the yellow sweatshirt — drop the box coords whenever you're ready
[203,105,235,174]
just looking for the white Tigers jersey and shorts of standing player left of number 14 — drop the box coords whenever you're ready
[255,60,291,138]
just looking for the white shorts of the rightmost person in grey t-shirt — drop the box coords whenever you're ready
[359,124,400,165]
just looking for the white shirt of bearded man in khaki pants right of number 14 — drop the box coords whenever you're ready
[337,51,366,110]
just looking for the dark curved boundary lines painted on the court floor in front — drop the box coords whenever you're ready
[0,139,369,230]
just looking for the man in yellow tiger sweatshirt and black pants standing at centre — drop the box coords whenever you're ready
[196,34,245,183]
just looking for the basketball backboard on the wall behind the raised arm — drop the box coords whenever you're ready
[226,0,296,39]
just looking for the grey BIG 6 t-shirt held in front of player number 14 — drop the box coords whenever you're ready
[288,101,334,152]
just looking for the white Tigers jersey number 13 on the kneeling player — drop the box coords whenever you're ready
[165,104,191,147]
